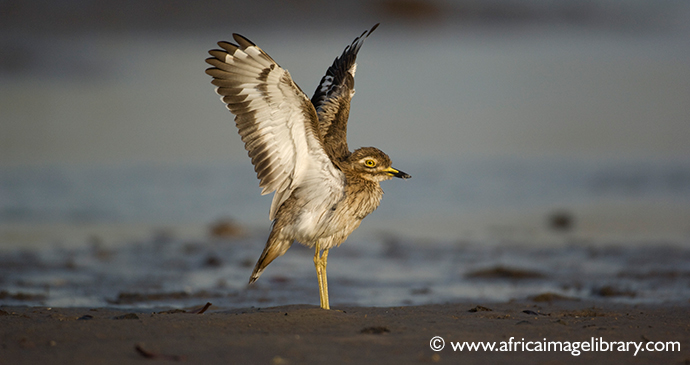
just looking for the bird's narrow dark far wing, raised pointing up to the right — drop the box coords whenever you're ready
[311,24,379,164]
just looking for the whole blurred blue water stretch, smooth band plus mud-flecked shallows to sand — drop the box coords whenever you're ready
[0,159,690,307]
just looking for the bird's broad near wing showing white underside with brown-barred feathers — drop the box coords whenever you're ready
[206,34,344,220]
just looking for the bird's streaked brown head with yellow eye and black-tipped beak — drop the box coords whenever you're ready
[345,147,411,182]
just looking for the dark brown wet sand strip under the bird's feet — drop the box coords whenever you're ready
[0,297,690,364]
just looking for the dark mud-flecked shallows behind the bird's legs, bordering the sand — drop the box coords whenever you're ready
[0,228,690,308]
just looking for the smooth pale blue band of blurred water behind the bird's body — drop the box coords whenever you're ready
[0,159,690,233]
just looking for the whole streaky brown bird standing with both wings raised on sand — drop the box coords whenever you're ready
[206,24,411,309]
